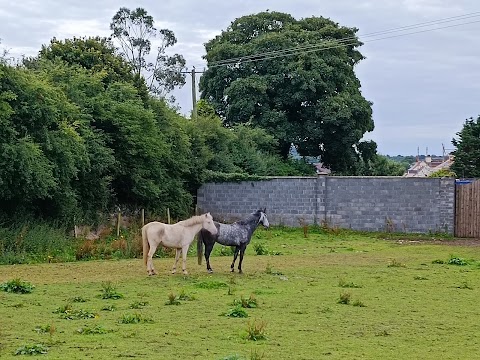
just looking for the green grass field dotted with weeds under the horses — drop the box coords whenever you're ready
[0,228,480,360]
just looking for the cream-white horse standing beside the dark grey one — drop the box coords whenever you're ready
[142,213,217,275]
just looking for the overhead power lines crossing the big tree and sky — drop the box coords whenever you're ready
[195,12,480,68]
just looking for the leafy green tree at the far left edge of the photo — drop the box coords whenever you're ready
[0,65,88,220]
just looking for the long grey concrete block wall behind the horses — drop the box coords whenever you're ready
[197,176,455,234]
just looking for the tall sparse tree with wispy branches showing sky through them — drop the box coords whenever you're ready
[110,7,185,97]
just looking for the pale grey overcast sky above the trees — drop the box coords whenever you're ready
[0,0,480,155]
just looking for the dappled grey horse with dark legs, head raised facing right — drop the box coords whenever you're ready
[197,209,270,273]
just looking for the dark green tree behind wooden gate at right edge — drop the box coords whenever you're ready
[451,116,480,178]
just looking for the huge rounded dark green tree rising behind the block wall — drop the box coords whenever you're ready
[200,12,374,174]
